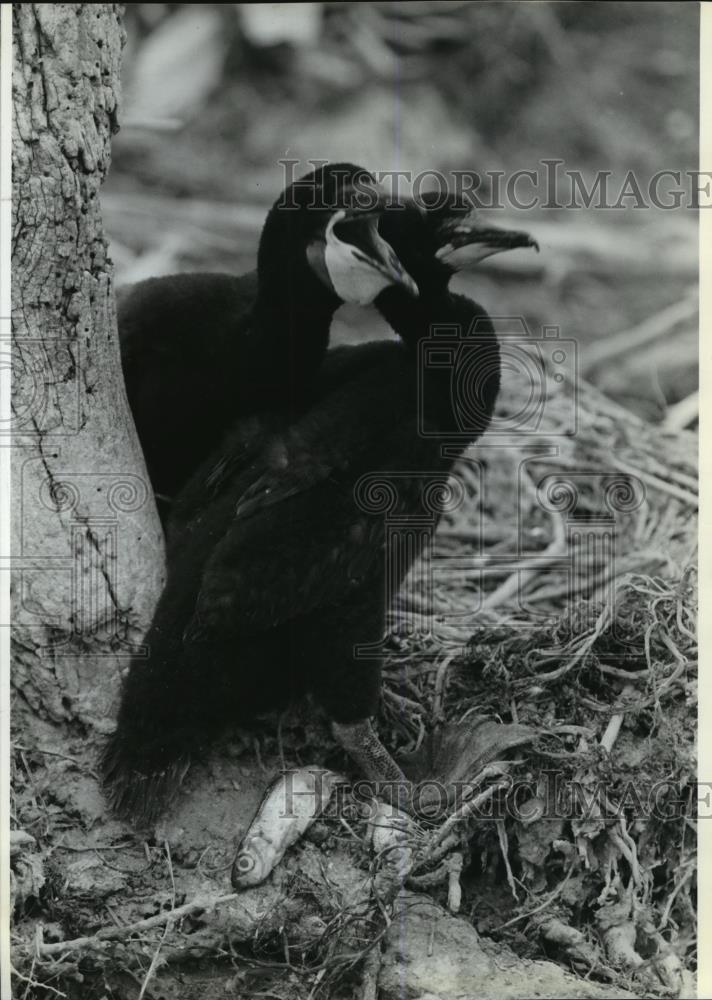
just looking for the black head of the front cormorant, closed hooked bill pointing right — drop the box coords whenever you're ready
[379,193,539,293]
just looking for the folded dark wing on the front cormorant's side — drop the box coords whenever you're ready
[184,344,406,641]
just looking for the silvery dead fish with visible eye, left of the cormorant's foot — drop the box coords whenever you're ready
[232,766,344,889]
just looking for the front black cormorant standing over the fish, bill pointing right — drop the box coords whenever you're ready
[103,191,535,822]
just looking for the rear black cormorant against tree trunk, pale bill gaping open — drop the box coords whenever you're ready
[118,163,415,515]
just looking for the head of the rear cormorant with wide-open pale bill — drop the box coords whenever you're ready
[257,163,418,305]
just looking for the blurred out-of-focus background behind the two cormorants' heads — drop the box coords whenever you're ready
[103,0,699,427]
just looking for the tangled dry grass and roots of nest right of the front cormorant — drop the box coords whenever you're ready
[383,374,697,995]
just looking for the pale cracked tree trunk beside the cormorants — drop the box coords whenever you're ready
[12,4,164,731]
